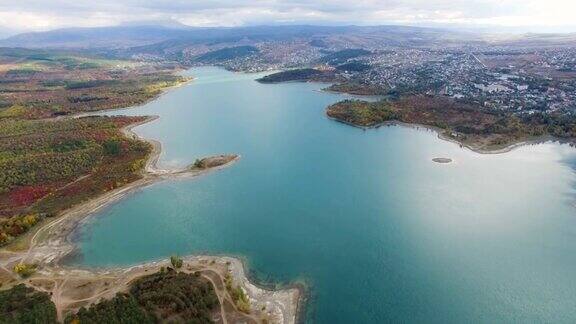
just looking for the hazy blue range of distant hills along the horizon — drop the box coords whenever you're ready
[0,22,576,52]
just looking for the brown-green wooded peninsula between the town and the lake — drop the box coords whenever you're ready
[326,96,576,152]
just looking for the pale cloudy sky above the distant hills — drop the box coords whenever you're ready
[0,0,576,32]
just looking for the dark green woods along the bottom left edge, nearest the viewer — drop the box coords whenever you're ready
[0,268,219,324]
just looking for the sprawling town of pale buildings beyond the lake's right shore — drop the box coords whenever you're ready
[178,40,576,114]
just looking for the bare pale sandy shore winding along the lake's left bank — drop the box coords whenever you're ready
[0,108,302,324]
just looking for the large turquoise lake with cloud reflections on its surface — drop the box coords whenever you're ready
[73,68,576,323]
